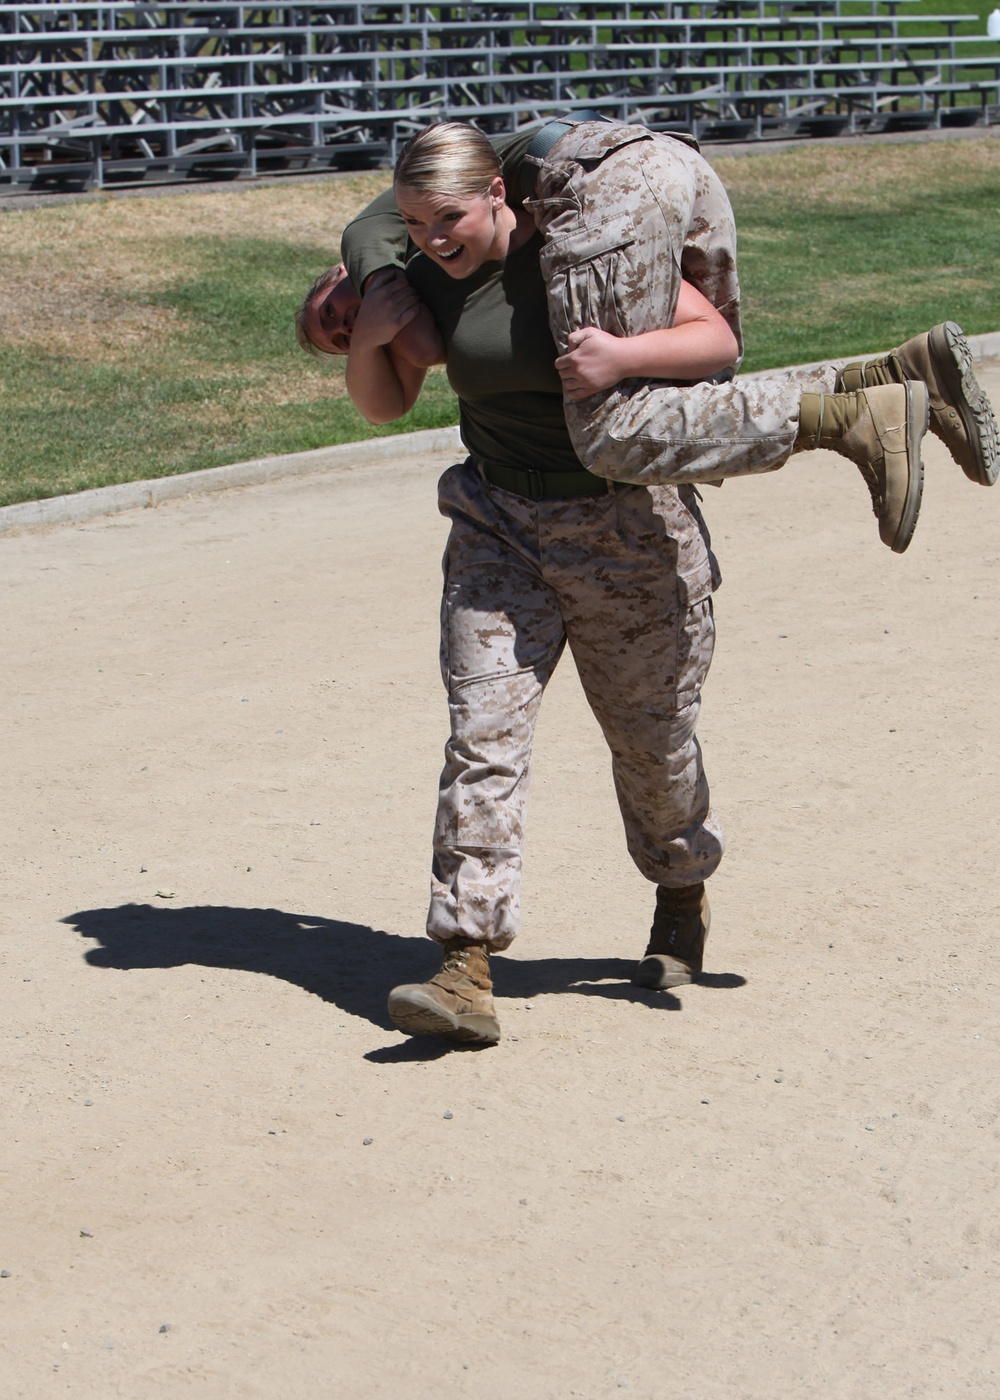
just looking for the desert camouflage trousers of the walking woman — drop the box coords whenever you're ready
[427,462,723,949]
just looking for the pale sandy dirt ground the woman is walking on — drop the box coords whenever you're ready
[0,365,1000,1400]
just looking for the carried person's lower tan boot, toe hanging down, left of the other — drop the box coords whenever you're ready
[793,379,930,554]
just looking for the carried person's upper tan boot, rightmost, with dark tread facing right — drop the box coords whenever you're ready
[836,321,1000,486]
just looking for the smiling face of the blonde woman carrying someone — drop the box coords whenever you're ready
[395,176,511,279]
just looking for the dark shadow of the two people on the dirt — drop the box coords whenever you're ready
[62,904,745,1052]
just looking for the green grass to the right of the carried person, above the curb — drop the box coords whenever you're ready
[732,143,1000,371]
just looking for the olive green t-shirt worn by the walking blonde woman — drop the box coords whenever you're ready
[406,226,583,472]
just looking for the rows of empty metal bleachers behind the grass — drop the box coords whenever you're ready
[0,0,1000,190]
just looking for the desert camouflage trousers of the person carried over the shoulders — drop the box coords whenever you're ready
[525,122,836,483]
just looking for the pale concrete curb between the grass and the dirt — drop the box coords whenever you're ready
[0,330,1000,535]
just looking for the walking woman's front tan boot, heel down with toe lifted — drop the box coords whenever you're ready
[389,938,500,1044]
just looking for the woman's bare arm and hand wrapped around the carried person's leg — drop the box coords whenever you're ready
[556,281,739,402]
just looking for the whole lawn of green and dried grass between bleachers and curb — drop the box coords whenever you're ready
[0,139,1000,504]
